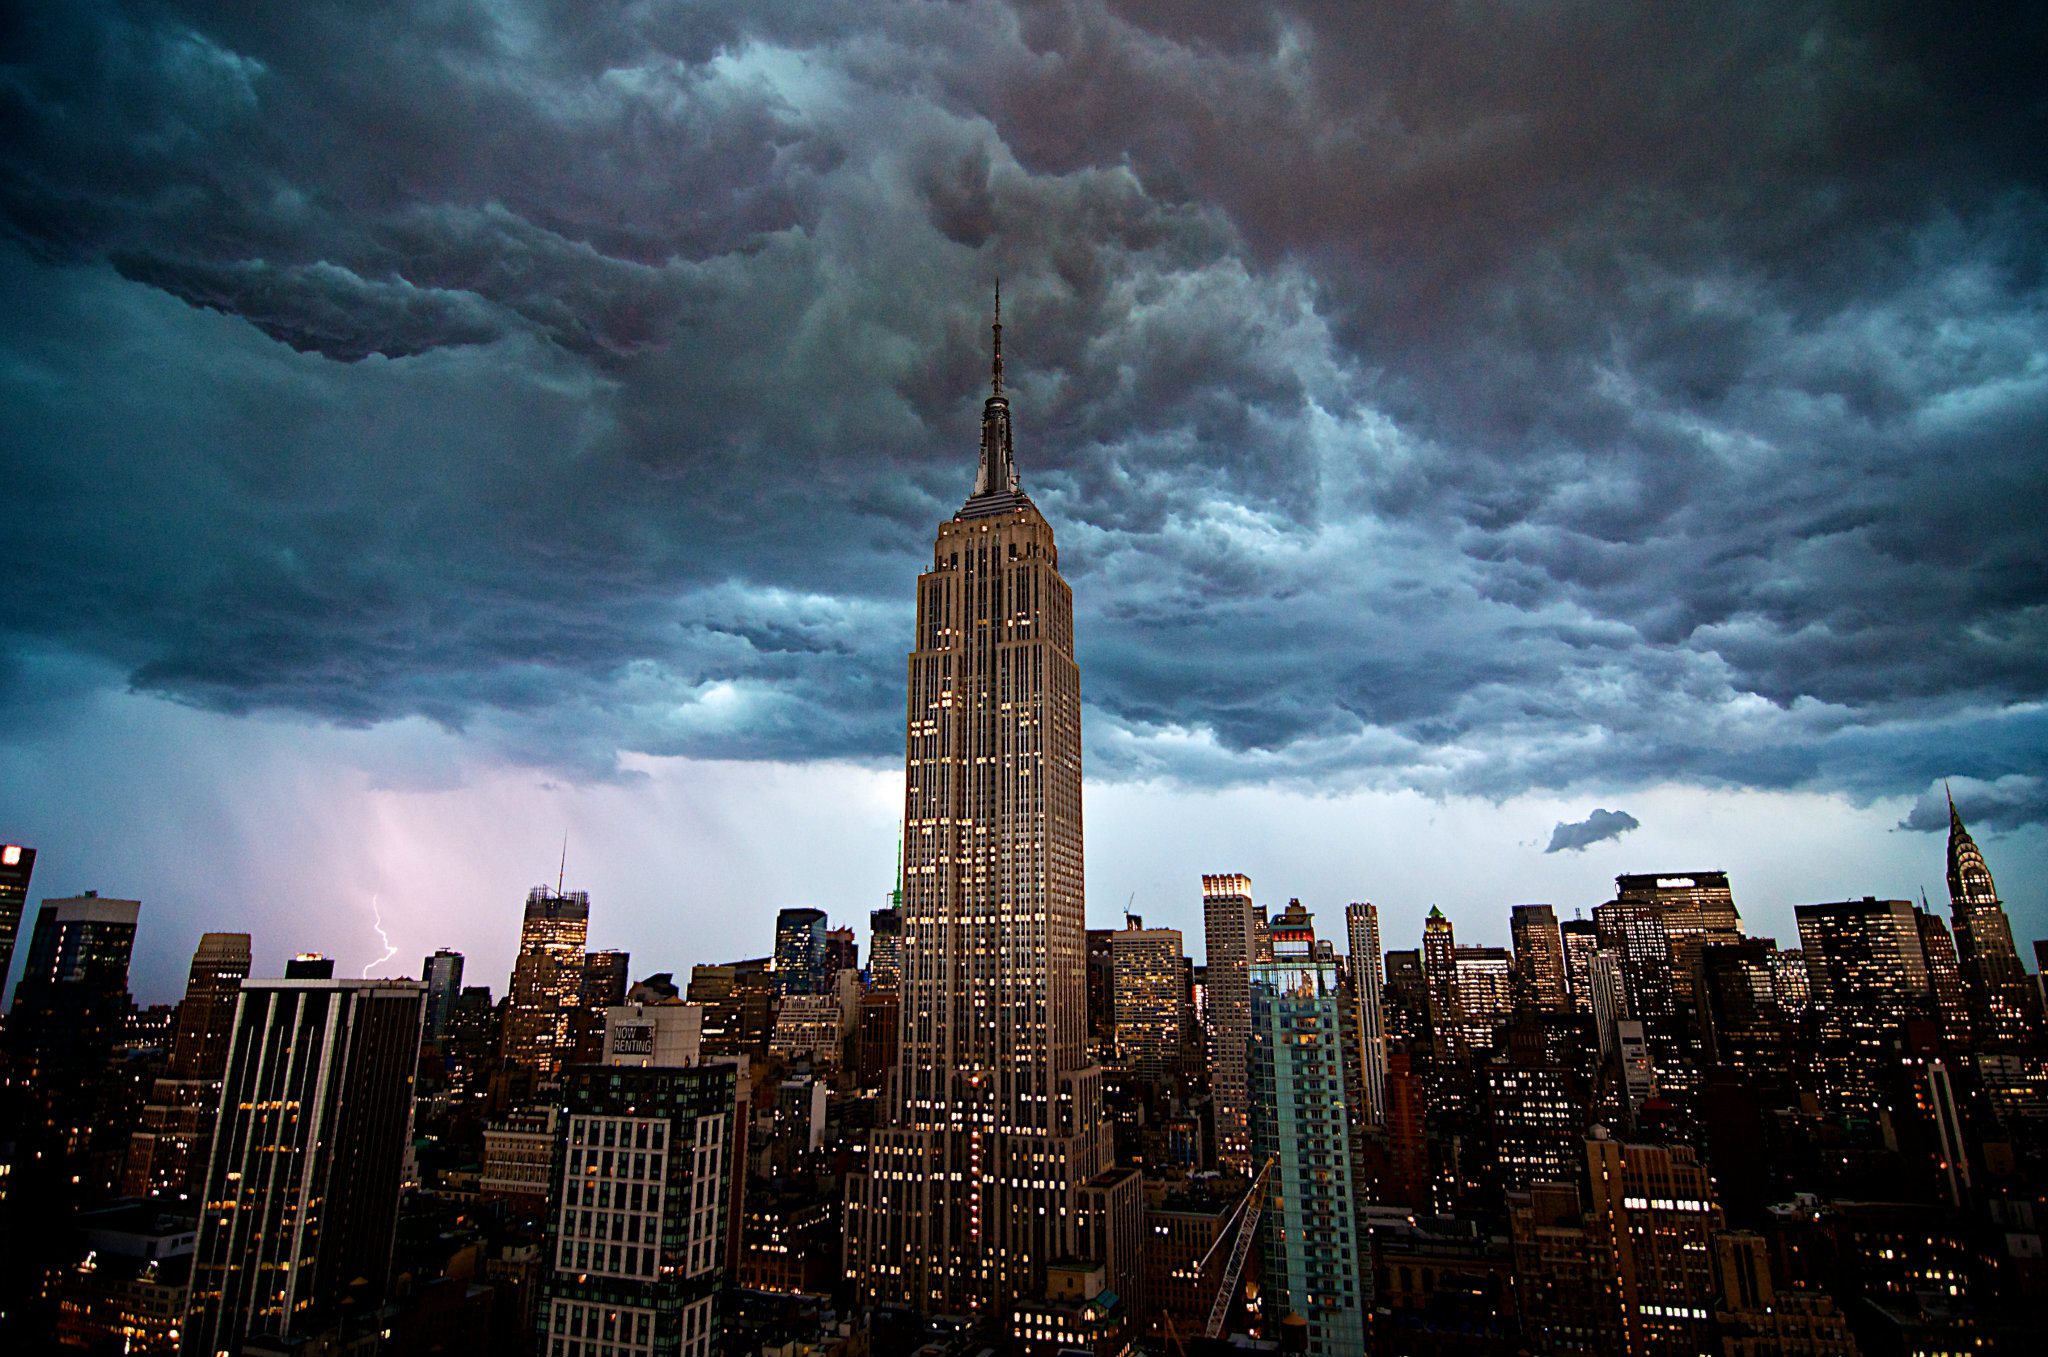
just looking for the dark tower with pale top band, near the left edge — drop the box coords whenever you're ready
[6,892,141,1154]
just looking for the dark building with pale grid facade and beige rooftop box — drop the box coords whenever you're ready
[539,1003,737,1357]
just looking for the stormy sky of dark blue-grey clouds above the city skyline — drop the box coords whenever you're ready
[0,0,2048,999]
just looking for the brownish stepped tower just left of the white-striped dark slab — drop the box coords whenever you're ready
[121,933,250,1197]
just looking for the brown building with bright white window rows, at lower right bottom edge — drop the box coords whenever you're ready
[1585,1132,1720,1355]
